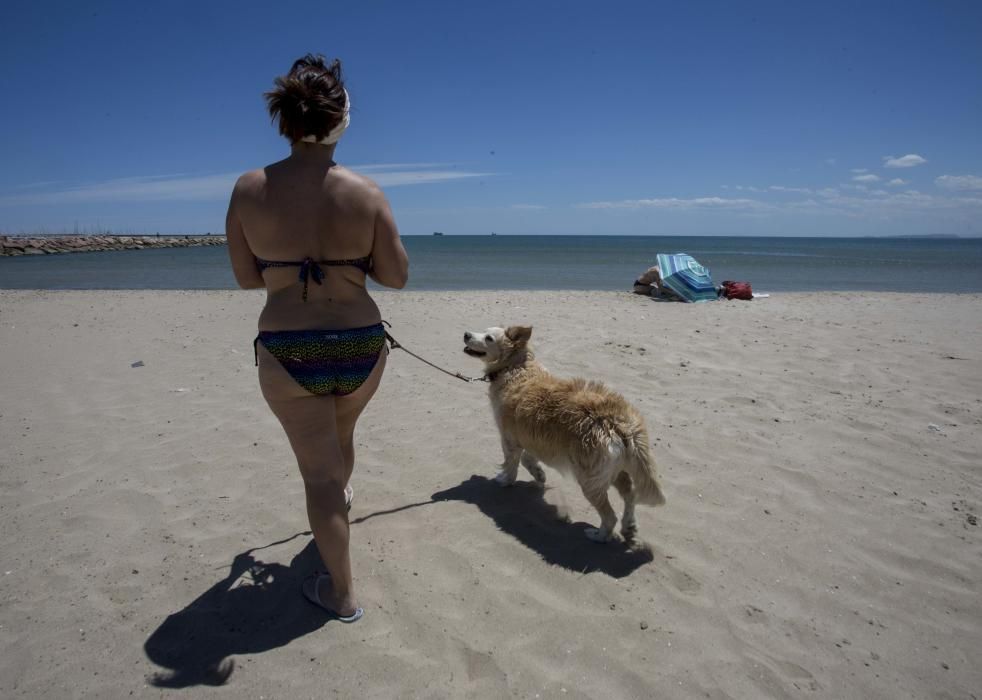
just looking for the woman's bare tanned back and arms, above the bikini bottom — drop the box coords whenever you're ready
[229,147,405,330]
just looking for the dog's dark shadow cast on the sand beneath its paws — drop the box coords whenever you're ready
[432,475,654,578]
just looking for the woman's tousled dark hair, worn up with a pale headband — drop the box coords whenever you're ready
[265,54,347,143]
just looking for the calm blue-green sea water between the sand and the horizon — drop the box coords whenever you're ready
[0,236,982,292]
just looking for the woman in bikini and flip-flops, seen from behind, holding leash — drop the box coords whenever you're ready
[226,54,409,622]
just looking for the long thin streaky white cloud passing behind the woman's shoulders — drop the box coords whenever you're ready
[0,163,492,206]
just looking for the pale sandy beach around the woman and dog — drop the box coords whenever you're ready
[0,291,982,699]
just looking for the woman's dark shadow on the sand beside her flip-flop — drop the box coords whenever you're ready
[143,532,328,688]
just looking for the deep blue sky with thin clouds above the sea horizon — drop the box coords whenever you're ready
[0,0,982,236]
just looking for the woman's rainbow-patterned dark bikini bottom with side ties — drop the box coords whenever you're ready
[253,323,385,396]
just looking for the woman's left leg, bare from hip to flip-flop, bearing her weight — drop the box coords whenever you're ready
[258,344,358,615]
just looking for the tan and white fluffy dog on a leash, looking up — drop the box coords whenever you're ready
[464,326,665,542]
